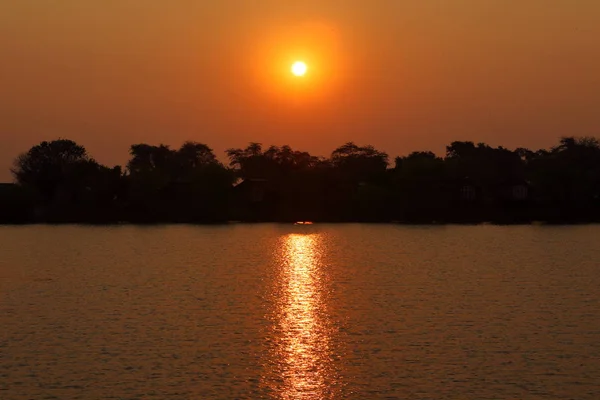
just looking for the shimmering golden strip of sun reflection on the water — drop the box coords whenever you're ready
[277,234,335,400]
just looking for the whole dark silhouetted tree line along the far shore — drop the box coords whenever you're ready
[0,137,600,223]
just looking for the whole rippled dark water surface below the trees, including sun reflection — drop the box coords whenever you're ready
[0,225,600,400]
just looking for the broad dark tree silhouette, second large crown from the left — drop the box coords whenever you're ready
[127,142,233,222]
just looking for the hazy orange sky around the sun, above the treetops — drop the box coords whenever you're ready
[0,0,600,181]
